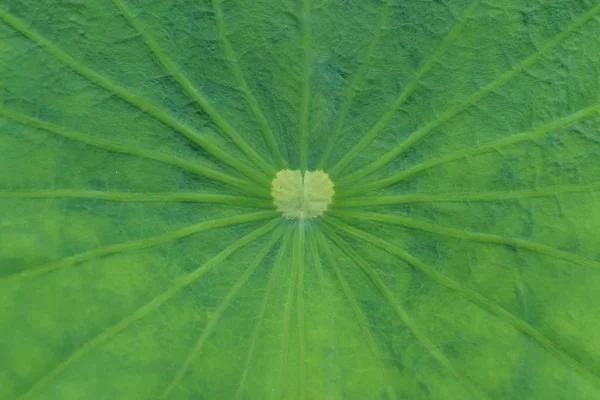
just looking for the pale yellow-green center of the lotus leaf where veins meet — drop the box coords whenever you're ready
[271,169,334,219]
